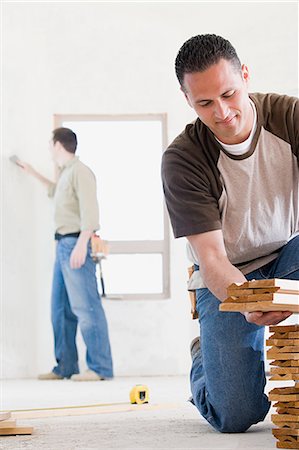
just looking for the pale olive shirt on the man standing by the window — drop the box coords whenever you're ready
[48,156,99,234]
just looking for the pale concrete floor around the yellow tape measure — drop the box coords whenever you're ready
[0,376,284,450]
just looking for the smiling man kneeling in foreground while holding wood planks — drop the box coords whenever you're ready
[162,35,299,432]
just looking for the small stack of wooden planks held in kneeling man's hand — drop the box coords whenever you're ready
[219,278,299,313]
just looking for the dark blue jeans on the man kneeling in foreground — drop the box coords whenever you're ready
[190,236,299,433]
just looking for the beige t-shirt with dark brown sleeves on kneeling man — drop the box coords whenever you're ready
[162,94,299,286]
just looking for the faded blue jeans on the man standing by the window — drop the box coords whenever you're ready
[51,237,113,378]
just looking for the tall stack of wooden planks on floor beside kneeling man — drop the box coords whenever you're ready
[266,325,299,449]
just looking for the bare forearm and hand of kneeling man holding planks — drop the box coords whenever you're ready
[187,230,291,325]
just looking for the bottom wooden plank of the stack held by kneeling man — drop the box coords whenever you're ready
[219,302,299,313]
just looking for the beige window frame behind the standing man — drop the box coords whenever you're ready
[54,113,170,300]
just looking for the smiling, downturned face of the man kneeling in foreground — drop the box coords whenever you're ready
[184,59,253,144]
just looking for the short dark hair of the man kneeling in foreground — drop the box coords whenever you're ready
[175,34,241,89]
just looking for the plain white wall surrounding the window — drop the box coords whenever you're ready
[1,2,298,377]
